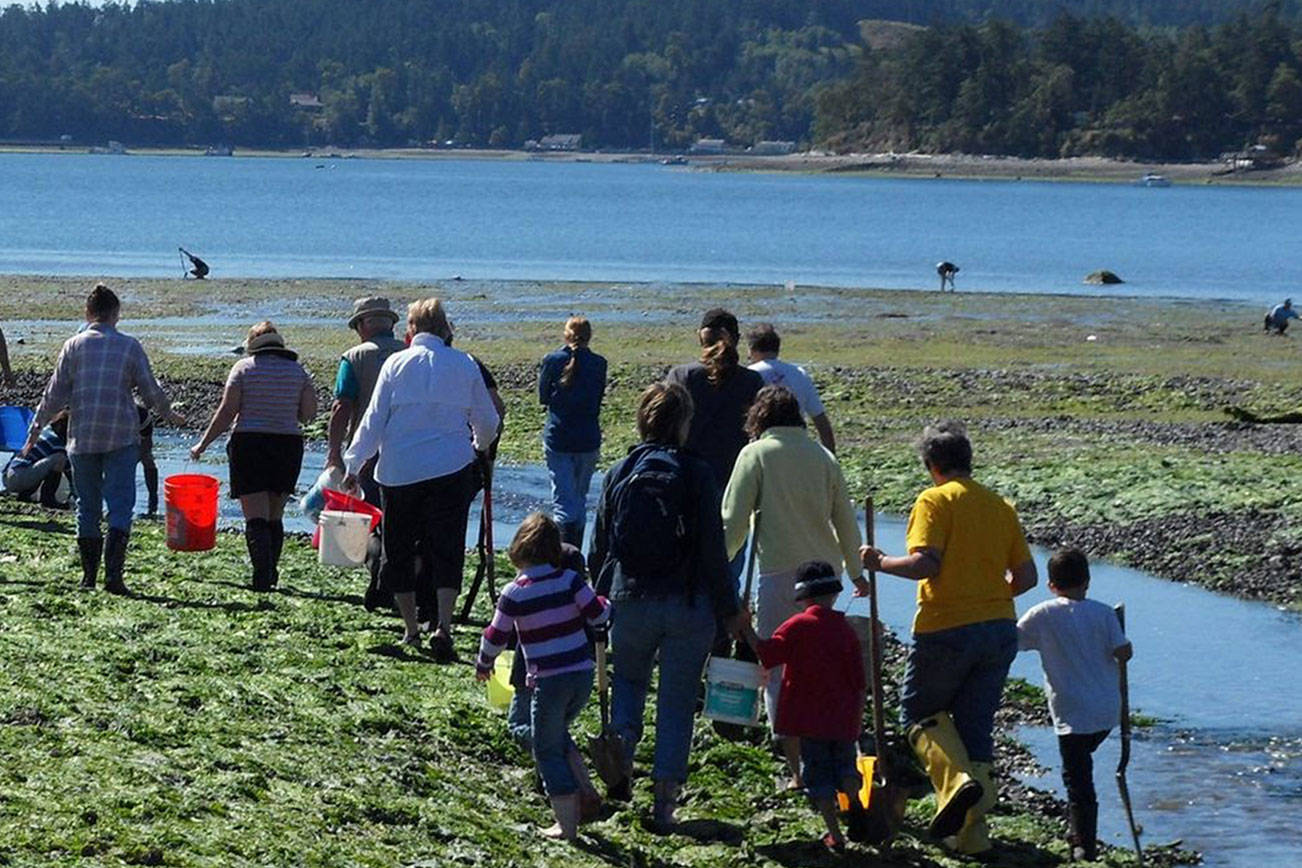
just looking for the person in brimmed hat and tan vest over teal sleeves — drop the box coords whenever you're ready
[326,295,406,506]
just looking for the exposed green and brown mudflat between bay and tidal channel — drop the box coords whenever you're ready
[0,277,1302,609]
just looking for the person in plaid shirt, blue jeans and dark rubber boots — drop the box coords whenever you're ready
[22,284,185,593]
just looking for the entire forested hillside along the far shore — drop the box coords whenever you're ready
[0,0,1302,157]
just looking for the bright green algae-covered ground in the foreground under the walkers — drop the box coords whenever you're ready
[0,501,1192,868]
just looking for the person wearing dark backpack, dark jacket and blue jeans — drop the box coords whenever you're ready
[589,383,743,832]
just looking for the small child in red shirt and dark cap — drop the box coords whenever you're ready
[742,561,867,851]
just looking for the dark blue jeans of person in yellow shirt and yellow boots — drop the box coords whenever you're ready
[900,619,1017,763]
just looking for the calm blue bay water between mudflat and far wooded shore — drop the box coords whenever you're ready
[0,149,1302,305]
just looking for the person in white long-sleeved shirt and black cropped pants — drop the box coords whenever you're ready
[344,298,500,661]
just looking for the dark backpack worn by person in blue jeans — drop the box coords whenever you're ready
[609,446,693,580]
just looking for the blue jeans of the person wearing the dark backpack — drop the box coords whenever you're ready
[611,593,715,783]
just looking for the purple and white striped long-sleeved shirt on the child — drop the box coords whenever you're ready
[477,563,611,682]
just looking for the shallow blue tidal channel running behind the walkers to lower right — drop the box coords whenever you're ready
[149,432,1302,868]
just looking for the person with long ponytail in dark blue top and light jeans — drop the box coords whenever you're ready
[538,316,605,548]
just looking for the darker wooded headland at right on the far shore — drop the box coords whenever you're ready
[814,4,1302,160]
